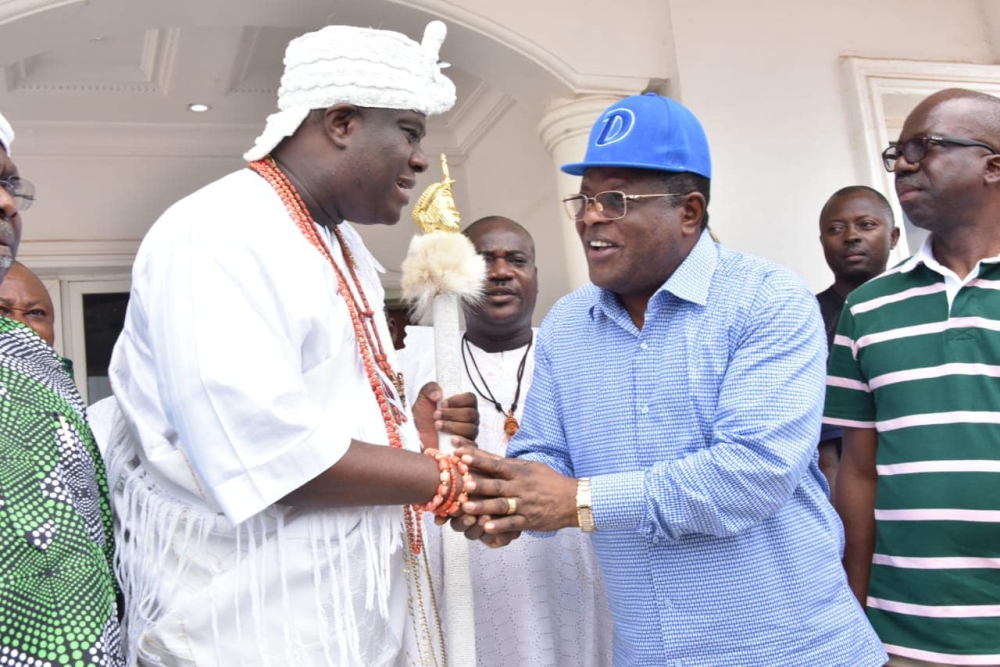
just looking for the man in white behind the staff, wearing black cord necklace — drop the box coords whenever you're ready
[400,216,612,667]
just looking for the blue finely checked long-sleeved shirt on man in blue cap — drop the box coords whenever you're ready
[508,234,886,667]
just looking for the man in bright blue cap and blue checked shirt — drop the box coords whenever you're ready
[453,95,886,667]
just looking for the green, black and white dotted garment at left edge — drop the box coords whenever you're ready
[0,318,124,667]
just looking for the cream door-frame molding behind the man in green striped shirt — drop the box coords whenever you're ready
[843,57,1000,260]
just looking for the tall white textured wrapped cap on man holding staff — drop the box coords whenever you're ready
[243,21,455,162]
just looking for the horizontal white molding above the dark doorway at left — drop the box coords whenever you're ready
[17,240,140,276]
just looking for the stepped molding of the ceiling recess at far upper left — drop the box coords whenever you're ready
[4,28,180,95]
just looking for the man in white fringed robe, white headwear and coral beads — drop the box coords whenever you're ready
[107,22,478,667]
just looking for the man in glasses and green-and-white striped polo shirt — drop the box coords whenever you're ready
[825,89,1000,665]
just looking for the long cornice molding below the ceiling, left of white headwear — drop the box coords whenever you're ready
[17,121,263,159]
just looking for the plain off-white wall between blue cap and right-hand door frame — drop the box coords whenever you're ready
[670,0,992,291]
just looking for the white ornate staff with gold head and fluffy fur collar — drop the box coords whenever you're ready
[402,154,486,667]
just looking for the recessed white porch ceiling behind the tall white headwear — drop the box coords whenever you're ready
[0,21,512,154]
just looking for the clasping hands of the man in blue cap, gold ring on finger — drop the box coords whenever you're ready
[452,450,578,546]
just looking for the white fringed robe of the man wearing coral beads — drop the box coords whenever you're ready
[107,170,418,667]
